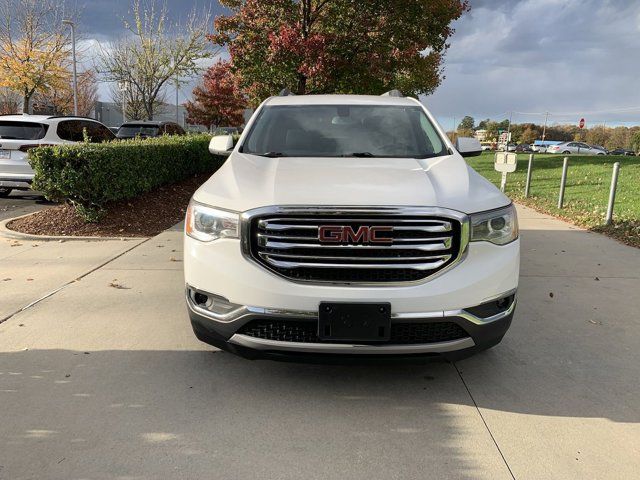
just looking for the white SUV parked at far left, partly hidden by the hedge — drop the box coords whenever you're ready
[0,115,115,197]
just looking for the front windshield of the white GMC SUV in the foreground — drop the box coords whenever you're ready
[241,105,447,158]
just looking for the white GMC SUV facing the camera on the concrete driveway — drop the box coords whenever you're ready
[184,95,520,358]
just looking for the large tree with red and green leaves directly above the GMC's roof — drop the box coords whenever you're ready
[210,0,468,105]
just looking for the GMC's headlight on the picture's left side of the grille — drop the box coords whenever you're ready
[185,200,238,242]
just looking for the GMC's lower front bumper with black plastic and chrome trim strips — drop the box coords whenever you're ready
[186,286,516,359]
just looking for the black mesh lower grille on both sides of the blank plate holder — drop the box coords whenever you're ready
[238,319,469,345]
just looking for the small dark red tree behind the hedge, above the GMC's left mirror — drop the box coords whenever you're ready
[185,60,247,128]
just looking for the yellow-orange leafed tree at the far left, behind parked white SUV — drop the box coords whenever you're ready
[0,0,74,112]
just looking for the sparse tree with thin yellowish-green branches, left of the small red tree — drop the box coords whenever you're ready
[98,0,214,120]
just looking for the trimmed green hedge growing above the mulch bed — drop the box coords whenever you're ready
[29,134,225,222]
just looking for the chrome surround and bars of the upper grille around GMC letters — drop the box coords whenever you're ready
[241,206,469,287]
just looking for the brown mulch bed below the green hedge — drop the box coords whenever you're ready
[7,174,211,237]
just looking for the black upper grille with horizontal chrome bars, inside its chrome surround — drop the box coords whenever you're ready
[248,210,462,284]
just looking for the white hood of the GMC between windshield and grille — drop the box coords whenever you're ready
[194,152,510,213]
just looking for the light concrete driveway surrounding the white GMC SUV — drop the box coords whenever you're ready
[0,204,640,480]
